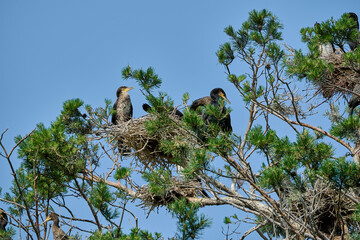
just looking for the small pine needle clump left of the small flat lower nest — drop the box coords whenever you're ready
[90,181,118,219]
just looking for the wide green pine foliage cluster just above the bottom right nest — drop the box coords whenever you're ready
[249,126,333,191]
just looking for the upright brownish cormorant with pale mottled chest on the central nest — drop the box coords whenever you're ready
[111,86,133,155]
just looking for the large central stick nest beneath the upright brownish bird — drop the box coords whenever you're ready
[108,115,197,168]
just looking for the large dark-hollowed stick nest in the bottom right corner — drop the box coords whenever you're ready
[286,179,360,236]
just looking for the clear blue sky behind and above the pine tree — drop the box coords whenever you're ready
[0,0,360,239]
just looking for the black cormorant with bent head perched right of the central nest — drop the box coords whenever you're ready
[190,88,232,141]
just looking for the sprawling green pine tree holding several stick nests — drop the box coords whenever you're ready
[0,10,360,239]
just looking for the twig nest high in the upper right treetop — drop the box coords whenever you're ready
[315,53,360,99]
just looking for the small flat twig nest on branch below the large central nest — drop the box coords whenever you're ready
[137,177,201,211]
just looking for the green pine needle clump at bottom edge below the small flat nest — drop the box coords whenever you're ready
[168,198,211,240]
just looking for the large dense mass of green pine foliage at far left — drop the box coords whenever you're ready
[15,99,96,202]
